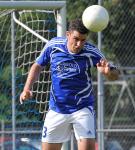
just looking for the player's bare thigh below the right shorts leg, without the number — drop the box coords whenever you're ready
[77,139,95,150]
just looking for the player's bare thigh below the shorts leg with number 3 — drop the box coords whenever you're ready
[42,142,62,150]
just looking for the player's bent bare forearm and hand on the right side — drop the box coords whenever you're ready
[97,59,120,81]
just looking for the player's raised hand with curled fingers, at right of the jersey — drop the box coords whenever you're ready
[97,59,110,75]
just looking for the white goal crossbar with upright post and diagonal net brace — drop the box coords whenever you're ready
[0,1,66,37]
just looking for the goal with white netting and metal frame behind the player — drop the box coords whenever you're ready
[0,1,66,147]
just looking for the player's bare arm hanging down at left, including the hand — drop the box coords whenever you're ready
[20,63,42,104]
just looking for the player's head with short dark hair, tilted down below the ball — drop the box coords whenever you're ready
[66,19,89,53]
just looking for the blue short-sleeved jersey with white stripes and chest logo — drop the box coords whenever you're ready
[36,37,104,114]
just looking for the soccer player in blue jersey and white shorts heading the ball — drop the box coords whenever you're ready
[20,19,119,150]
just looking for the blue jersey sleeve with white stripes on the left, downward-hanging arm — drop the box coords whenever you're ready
[36,42,52,66]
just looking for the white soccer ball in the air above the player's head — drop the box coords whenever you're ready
[82,5,109,32]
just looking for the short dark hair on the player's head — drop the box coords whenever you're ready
[68,19,89,34]
